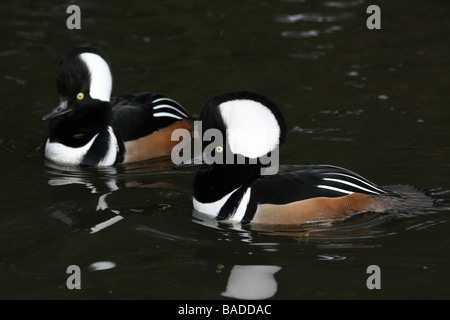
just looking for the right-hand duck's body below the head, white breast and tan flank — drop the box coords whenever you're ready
[193,165,397,224]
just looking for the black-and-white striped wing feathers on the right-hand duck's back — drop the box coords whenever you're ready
[317,166,389,195]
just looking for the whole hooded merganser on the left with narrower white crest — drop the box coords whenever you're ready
[42,47,192,166]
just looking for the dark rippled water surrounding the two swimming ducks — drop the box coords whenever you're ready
[0,0,450,299]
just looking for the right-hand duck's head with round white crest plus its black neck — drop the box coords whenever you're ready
[177,91,287,201]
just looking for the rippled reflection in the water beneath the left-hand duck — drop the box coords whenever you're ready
[46,157,180,233]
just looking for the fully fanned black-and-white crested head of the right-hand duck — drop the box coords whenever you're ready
[179,91,287,167]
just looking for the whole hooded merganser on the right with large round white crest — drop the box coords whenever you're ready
[175,92,424,224]
